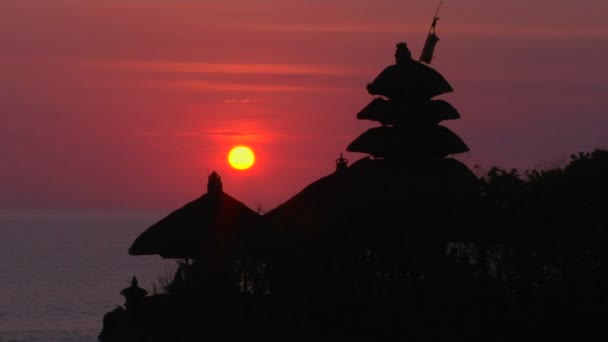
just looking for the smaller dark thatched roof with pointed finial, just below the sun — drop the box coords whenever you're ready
[129,172,260,258]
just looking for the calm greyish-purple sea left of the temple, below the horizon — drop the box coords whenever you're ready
[0,211,175,342]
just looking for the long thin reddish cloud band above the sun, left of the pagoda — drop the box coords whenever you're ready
[79,60,365,93]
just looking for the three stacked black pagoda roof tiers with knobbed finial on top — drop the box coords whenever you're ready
[347,43,469,160]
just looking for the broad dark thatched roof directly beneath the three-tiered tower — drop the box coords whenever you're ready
[264,158,480,249]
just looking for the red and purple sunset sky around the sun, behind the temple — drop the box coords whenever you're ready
[0,0,608,211]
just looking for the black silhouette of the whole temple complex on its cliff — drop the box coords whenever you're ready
[99,43,608,342]
